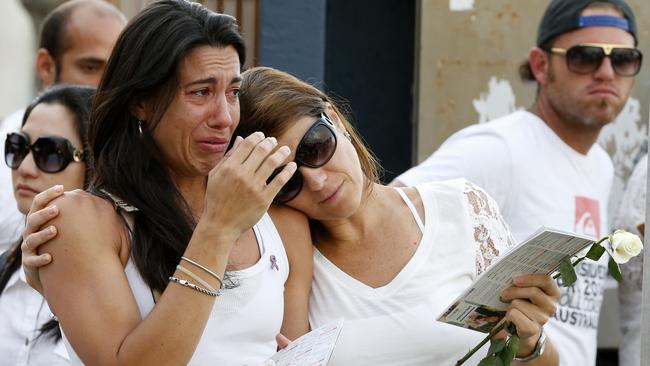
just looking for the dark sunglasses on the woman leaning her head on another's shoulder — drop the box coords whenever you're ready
[267,114,336,203]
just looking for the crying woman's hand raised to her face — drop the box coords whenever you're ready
[202,132,296,238]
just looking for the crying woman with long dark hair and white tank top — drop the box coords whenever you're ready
[15,0,312,366]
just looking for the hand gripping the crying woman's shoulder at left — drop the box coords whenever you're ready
[20,185,63,293]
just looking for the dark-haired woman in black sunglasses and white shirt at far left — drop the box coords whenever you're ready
[0,85,95,365]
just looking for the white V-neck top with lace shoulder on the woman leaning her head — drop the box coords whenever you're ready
[309,179,513,366]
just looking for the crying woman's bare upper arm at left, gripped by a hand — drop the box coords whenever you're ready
[39,191,140,364]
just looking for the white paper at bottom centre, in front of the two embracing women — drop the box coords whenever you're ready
[265,318,343,366]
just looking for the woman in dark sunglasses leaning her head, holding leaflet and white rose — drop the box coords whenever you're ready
[235,67,559,365]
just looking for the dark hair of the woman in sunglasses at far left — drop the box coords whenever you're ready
[0,84,95,341]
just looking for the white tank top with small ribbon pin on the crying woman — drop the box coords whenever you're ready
[64,214,289,366]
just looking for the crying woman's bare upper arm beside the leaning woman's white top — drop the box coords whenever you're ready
[269,205,314,340]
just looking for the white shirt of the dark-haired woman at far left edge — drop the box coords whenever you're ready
[0,267,69,366]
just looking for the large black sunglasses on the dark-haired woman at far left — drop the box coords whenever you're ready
[5,132,84,173]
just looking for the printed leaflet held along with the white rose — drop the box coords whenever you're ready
[438,227,595,333]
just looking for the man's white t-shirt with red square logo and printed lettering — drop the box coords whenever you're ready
[397,111,614,366]
